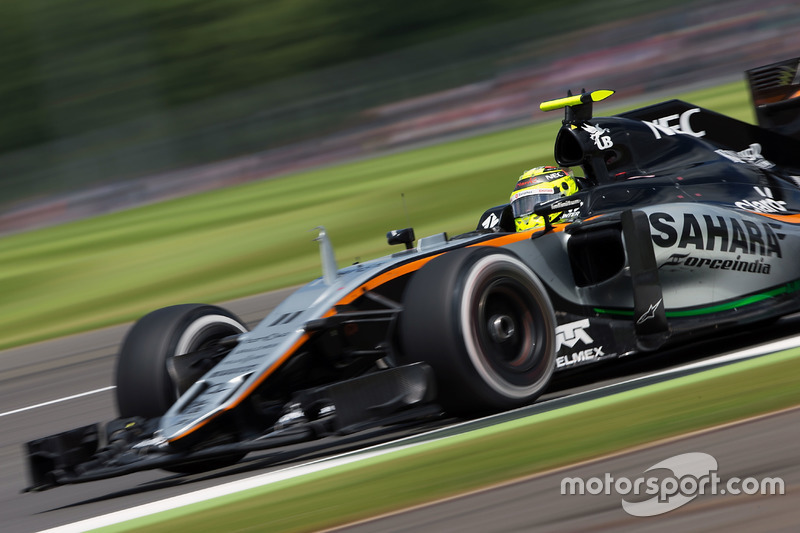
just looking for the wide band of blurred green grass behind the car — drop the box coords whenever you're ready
[0,83,752,348]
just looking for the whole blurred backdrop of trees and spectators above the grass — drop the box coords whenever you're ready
[0,0,800,234]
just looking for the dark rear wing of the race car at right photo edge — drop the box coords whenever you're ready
[746,58,800,139]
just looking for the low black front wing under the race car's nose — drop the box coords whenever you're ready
[25,363,442,491]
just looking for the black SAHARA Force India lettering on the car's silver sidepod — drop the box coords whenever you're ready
[649,212,785,274]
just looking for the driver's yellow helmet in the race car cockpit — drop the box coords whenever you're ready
[511,166,578,231]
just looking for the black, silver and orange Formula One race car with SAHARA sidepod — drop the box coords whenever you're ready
[21,59,800,490]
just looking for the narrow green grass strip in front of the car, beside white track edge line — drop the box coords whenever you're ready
[103,349,800,533]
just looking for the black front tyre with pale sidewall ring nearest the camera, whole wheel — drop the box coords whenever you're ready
[400,248,556,416]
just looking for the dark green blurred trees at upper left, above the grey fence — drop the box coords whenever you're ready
[0,0,676,152]
